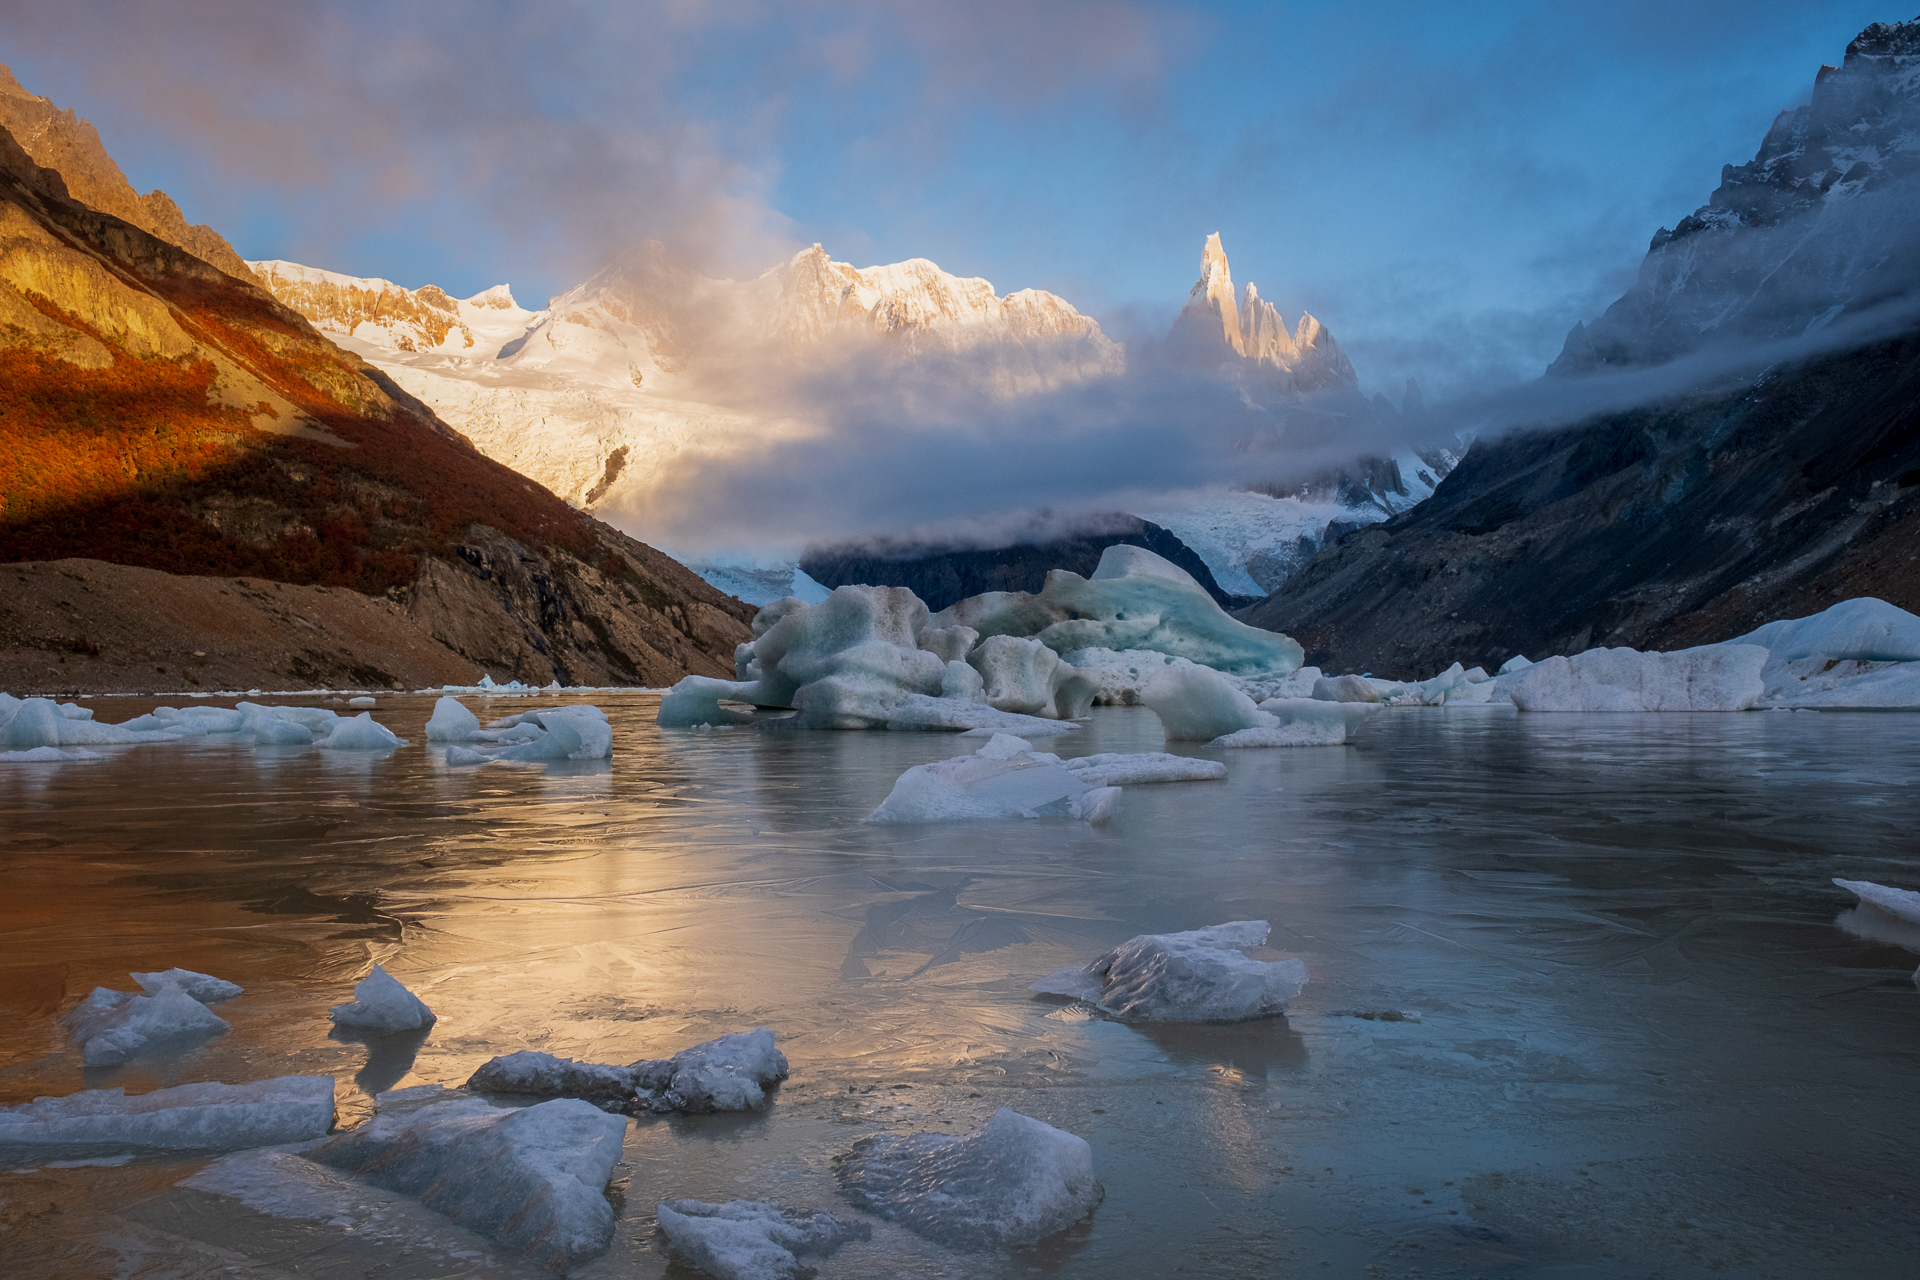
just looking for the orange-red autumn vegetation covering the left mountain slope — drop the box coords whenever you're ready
[0,280,593,593]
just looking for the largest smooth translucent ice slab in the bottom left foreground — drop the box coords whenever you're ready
[307,1096,626,1272]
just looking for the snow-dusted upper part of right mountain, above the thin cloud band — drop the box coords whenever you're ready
[1549,19,1920,374]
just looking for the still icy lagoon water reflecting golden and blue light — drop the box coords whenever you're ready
[0,693,1920,1278]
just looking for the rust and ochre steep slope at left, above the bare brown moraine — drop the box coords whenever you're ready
[0,111,749,683]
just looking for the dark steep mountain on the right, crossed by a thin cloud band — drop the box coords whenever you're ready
[1242,23,1920,677]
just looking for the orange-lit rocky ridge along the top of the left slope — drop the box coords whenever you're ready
[0,67,253,282]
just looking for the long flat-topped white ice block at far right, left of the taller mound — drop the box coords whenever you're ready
[1509,645,1766,712]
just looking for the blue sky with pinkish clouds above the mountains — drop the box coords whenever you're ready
[0,0,1908,399]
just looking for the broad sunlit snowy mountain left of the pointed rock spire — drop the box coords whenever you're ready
[252,242,1121,529]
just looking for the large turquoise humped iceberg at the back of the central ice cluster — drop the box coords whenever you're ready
[933,545,1302,676]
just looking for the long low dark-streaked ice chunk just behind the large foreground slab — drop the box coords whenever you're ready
[467,1027,787,1115]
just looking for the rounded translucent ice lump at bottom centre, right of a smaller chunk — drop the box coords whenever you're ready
[833,1107,1100,1249]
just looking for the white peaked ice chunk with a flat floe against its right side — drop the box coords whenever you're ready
[866,733,1117,823]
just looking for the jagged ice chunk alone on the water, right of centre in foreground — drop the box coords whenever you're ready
[1031,919,1308,1023]
